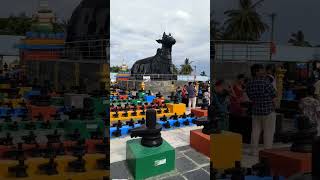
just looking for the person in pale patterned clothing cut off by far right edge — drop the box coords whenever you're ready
[299,87,320,135]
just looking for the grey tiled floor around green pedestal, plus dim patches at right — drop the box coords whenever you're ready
[110,124,289,180]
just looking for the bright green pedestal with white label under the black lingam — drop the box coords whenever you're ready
[127,138,175,180]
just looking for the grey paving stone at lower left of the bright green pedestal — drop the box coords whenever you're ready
[110,161,132,179]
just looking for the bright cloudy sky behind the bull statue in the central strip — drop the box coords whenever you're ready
[110,0,210,74]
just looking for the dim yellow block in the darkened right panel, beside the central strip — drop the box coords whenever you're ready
[210,131,242,170]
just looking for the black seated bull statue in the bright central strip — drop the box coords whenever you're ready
[131,32,177,80]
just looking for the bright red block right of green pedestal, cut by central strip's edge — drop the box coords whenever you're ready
[190,129,210,157]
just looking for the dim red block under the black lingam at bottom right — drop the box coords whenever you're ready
[259,148,311,177]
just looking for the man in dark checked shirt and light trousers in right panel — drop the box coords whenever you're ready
[247,64,276,156]
